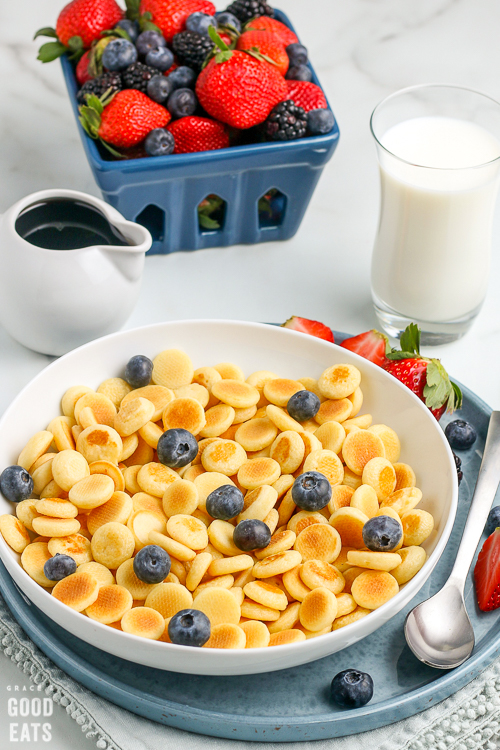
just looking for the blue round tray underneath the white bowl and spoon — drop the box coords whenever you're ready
[0,334,500,742]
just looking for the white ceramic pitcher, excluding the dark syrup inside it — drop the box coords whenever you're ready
[0,190,152,355]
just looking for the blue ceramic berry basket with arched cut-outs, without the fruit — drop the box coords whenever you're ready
[62,10,339,254]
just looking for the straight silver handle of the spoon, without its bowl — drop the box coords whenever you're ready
[449,411,500,590]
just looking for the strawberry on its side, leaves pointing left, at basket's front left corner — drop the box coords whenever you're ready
[80,89,170,152]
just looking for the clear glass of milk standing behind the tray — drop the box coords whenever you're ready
[370,84,500,344]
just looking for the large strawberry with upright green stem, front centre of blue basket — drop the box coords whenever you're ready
[196,27,287,129]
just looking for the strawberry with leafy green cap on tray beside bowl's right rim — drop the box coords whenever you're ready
[384,323,462,420]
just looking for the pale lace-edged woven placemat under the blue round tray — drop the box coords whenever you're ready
[0,596,500,750]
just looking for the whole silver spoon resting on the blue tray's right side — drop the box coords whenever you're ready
[405,411,500,669]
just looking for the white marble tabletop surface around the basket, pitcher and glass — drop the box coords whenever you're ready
[0,0,500,750]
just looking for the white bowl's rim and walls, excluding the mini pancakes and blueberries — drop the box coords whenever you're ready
[0,320,458,675]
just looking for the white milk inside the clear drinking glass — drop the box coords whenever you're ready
[372,117,500,321]
